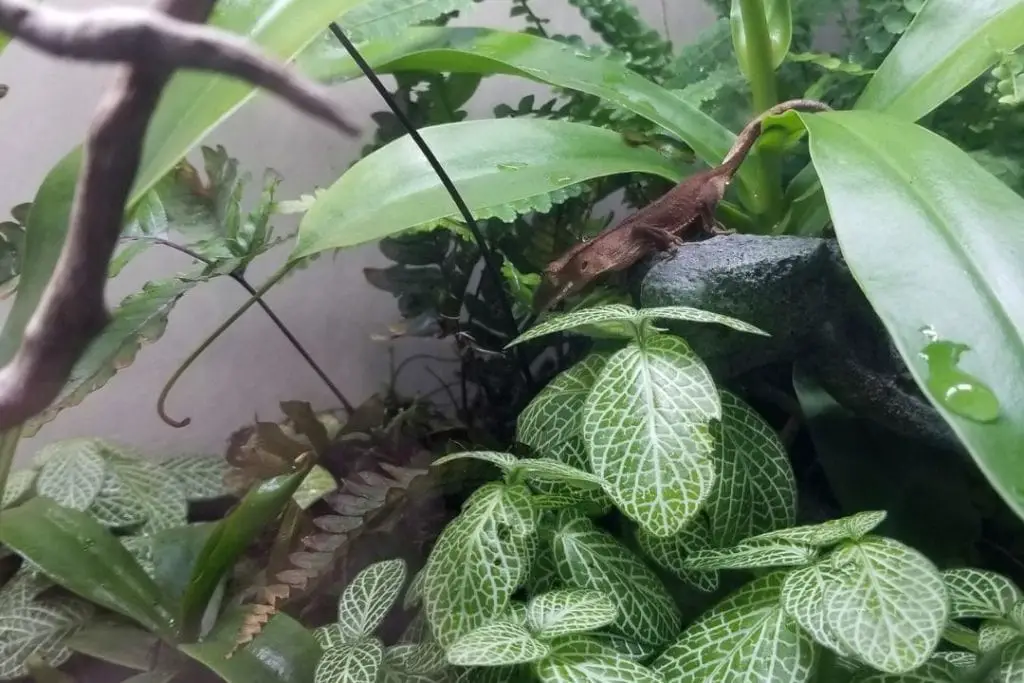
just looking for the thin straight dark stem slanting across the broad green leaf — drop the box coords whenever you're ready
[331,22,535,389]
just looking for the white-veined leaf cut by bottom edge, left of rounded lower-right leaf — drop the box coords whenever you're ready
[651,571,815,683]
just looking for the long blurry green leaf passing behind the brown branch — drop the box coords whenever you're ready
[0,0,368,378]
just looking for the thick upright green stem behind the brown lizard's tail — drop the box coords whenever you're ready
[739,0,782,222]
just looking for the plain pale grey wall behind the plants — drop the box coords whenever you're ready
[0,0,714,463]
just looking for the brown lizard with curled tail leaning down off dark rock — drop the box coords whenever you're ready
[534,99,830,311]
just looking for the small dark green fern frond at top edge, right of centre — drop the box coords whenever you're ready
[569,0,672,81]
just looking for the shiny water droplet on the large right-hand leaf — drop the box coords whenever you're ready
[920,328,999,422]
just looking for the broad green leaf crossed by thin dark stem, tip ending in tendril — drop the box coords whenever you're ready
[290,119,679,261]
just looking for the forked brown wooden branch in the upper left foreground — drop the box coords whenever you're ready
[0,0,353,431]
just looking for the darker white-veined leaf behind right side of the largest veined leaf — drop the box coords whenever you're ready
[707,391,797,548]
